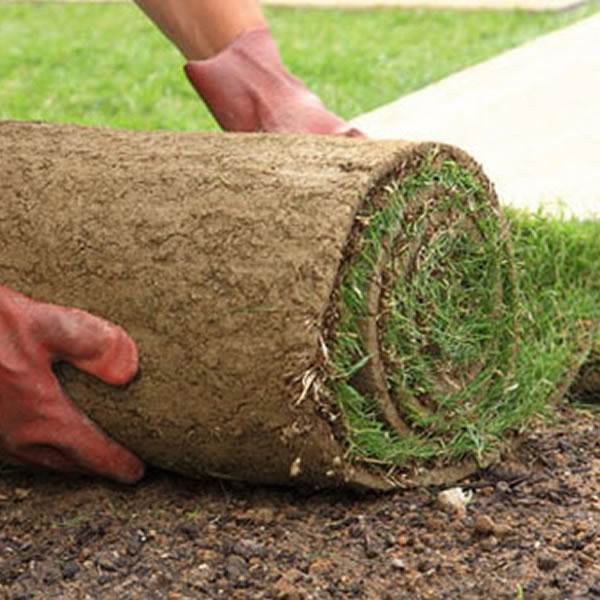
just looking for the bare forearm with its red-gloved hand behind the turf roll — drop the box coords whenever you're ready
[135,0,362,136]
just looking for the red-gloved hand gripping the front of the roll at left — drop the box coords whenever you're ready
[0,286,144,483]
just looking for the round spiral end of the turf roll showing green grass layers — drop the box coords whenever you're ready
[322,153,516,480]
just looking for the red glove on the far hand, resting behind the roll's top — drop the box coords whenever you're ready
[185,27,364,137]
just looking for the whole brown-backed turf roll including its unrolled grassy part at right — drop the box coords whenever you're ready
[0,122,600,489]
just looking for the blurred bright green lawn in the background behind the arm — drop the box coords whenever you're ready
[0,3,599,130]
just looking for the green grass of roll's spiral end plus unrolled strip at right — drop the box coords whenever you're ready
[329,155,600,468]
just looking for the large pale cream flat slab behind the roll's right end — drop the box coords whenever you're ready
[353,14,600,218]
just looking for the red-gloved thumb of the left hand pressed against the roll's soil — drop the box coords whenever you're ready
[32,304,138,385]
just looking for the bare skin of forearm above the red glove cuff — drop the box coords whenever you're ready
[135,0,266,60]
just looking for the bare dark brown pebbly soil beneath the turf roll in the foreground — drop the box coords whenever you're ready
[0,407,600,600]
